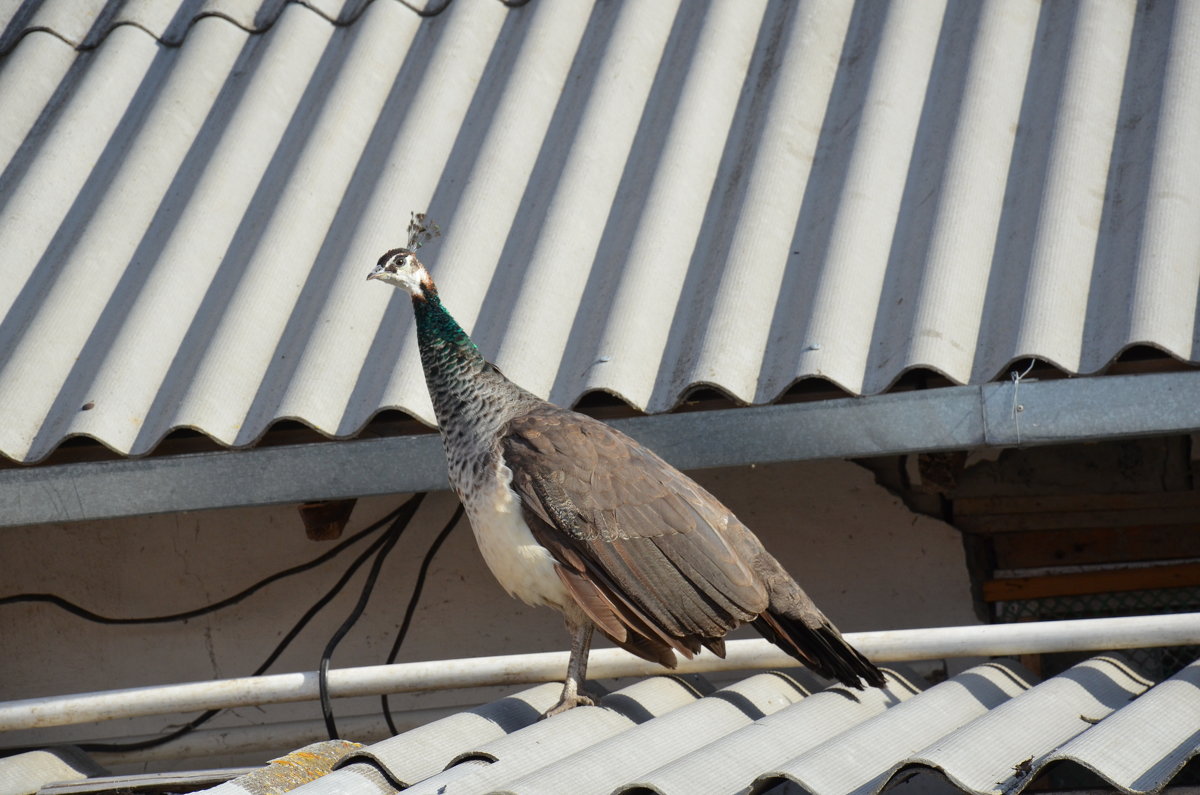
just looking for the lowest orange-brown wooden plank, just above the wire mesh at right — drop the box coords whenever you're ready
[983,563,1200,602]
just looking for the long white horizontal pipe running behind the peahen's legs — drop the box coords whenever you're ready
[0,612,1200,731]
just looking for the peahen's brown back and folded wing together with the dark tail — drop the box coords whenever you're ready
[500,406,883,687]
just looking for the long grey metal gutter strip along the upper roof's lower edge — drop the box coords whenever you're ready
[0,372,1200,527]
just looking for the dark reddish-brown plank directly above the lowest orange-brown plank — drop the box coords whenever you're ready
[988,524,1200,569]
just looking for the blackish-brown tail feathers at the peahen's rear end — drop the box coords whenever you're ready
[754,610,887,691]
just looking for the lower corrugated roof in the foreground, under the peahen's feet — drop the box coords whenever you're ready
[189,656,1200,795]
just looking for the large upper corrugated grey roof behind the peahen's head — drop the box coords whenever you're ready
[0,0,1200,461]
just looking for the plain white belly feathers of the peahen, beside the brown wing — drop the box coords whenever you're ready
[466,461,577,612]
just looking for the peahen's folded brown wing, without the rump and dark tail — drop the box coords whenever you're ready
[503,412,766,663]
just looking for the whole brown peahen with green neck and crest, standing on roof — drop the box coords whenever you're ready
[367,216,884,716]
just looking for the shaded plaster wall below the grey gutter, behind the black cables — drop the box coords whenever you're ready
[0,461,977,770]
